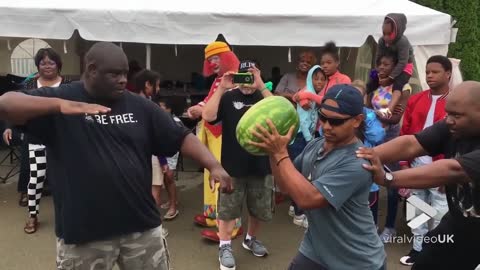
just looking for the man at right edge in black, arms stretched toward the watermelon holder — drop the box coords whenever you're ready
[357,81,480,270]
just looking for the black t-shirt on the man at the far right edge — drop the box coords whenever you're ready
[415,121,480,221]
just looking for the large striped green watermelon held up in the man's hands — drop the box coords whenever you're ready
[236,96,300,156]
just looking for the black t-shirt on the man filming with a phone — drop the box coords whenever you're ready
[212,89,270,177]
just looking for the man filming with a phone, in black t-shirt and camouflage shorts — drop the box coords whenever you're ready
[202,61,273,270]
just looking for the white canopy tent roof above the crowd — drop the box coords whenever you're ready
[0,0,451,47]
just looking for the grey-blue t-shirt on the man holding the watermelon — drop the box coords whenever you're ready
[294,138,386,270]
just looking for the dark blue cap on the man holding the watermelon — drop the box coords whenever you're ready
[321,84,364,116]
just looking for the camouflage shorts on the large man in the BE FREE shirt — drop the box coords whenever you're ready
[57,226,169,270]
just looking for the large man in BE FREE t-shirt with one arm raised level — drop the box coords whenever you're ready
[0,42,231,270]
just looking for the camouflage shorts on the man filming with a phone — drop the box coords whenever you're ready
[217,175,274,221]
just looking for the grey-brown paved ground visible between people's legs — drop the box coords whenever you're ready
[0,153,410,270]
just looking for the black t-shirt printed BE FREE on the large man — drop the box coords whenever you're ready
[25,82,189,244]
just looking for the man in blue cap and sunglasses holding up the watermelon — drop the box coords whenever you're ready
[252,85,386,270]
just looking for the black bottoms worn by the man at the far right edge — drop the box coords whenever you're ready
[412,213,480,270]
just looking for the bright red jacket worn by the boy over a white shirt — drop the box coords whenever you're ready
[400,90,448,165]
